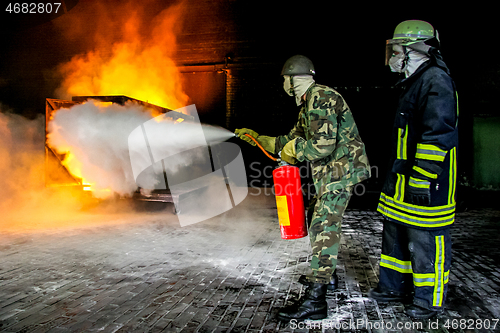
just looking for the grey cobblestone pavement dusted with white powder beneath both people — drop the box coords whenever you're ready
[0,189,500,332]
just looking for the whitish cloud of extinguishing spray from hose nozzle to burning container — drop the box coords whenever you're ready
[47,101,234,198]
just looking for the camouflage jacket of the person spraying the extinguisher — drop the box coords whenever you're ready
[276,84,370,197]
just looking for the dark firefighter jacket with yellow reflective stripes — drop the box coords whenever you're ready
[378,53,458,229]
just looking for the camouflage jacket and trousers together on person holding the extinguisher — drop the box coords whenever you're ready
[275,84,370,283]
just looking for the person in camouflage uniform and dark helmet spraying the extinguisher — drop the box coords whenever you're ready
[236,55,370,321]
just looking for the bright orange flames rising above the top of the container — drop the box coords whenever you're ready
[53,2,189,109]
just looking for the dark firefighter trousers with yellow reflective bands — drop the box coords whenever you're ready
[379,219,451,310]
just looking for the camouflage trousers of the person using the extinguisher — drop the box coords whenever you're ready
[307,186,352,283]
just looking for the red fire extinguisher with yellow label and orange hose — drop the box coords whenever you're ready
[240,134,307,239]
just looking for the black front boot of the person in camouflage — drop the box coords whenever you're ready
[278,283,328,321]
